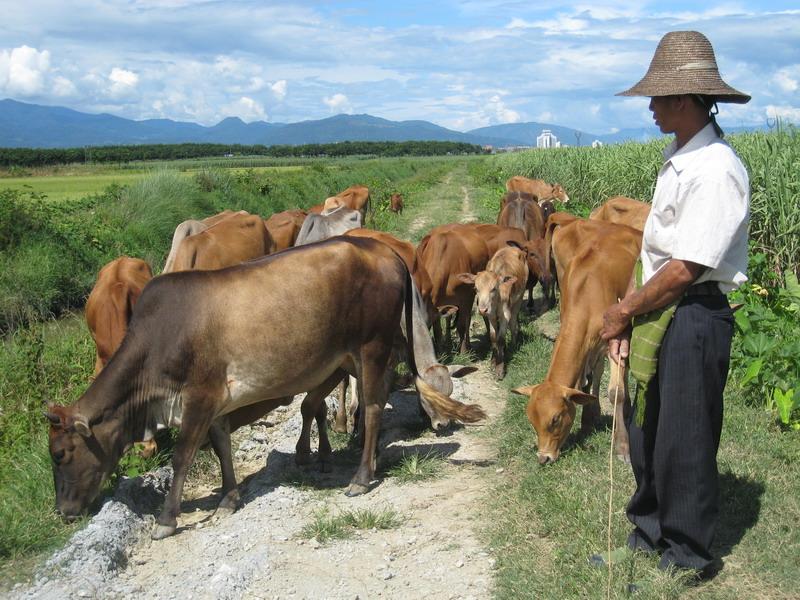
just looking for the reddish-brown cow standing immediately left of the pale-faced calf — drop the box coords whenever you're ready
[417,228,489,353]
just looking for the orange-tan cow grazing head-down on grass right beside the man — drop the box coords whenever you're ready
[514,219,642,464]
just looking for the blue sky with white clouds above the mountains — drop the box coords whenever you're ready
[0,0,800,134]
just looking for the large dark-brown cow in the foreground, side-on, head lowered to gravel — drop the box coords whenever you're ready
[51,238,485,539]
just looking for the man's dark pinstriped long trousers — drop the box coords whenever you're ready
[627,295,733,570]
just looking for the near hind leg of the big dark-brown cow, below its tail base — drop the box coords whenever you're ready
[345,343,392,496]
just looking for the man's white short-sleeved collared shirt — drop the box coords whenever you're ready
[641,123,750,293]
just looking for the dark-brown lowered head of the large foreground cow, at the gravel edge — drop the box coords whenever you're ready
[45,406,119,520]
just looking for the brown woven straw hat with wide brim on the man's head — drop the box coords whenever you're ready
[617,31,750,104]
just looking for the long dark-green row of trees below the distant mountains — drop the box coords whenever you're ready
[0,141,485,167]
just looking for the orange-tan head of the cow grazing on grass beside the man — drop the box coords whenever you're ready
[512,381,597,465]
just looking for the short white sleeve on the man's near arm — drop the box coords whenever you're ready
[672,174,748,269]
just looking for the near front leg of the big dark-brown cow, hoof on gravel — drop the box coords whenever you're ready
[151,398,213,540]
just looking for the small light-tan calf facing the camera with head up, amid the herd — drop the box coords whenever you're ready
[460,246,528,379]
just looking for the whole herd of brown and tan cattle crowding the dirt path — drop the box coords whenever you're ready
[47,177,649,539]
